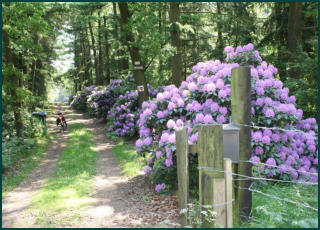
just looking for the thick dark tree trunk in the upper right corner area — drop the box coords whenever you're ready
[288,2,302,78]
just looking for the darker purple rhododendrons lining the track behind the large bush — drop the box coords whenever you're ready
[71,75,163,137]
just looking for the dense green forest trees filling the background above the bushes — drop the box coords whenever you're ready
[2,2,318,169]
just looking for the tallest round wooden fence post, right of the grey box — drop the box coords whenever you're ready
[231,66,252,222]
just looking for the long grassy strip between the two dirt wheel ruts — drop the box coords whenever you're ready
[30,124,98,227]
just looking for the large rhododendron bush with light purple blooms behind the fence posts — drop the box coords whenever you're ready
[136,44,318,191]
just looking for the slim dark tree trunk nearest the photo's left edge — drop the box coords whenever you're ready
[2,28,23,137]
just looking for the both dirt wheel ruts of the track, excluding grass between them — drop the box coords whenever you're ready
[2,107,178,228]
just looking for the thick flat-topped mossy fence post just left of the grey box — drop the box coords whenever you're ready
[197,125,225,227]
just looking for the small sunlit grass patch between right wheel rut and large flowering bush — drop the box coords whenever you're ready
[112,141,146,177]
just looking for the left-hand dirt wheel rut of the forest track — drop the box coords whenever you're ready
[2,104,67,228]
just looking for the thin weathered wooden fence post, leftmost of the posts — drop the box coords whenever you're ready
[175,127,189,227]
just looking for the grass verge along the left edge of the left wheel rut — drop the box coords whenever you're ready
[2,136,51,199]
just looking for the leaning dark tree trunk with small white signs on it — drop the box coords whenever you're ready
[118,2,149,106]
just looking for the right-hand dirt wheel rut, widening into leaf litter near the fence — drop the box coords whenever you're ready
[71,107,178,228]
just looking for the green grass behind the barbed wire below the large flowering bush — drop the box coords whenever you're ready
[241,183,318,228]
